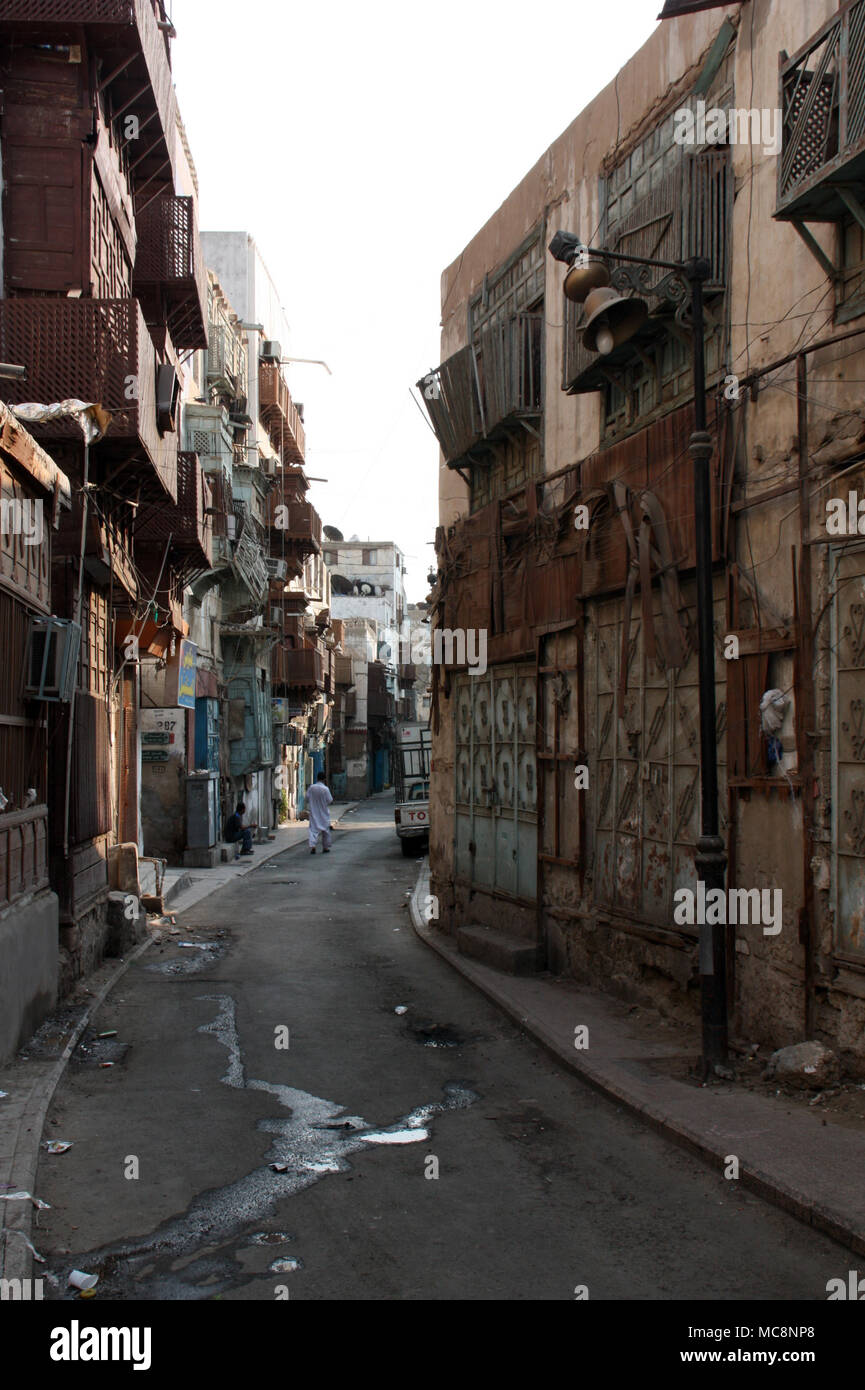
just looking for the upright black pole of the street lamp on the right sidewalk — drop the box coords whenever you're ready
[686,257,727,1077]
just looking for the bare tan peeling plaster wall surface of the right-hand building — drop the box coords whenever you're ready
[430,0,865,1056]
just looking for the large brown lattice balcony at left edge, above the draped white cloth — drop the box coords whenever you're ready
[0,297,178,502]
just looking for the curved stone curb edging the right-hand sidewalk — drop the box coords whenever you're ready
[409,859,865,1255]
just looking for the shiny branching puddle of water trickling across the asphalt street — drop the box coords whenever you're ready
[56,995,478,1301]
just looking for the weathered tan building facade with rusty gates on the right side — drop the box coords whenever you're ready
[419,0,865,1070]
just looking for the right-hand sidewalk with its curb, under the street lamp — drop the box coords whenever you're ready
[410,859,865,1255]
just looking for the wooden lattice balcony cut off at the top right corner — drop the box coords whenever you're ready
[775,0,865,221]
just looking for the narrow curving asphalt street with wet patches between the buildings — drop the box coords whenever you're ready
[33,796,851,1301]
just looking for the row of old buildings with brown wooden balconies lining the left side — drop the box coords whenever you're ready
[0,0,346,1058]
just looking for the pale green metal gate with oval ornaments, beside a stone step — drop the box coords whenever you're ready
[455,664,537,901]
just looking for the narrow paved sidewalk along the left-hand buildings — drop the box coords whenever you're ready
[0,801,359,1279]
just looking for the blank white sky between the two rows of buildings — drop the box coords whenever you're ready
[171,0,662,602]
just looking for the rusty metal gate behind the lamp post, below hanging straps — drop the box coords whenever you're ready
[585,585,727,927]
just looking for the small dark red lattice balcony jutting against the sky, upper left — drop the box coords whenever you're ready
[132,193,207,349]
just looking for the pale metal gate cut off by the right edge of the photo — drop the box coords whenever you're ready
[832,549,865,959]
